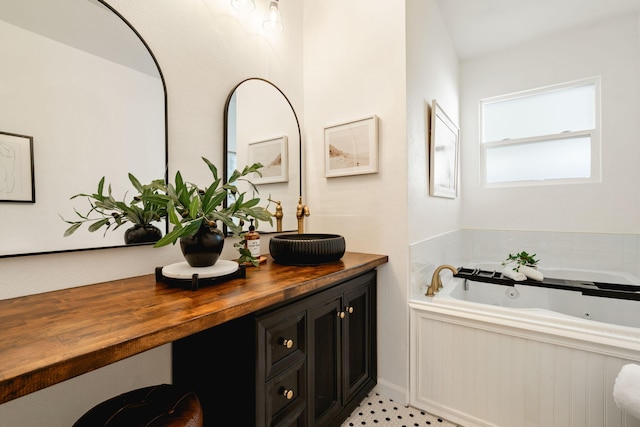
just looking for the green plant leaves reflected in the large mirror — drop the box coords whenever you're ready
[62,174,166,237]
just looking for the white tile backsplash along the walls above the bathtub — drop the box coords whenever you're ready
[409,229,640,297]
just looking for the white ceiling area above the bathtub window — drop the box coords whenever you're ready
[437,0,640,60]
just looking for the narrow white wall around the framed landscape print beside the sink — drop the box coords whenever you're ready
[304,0,408,401]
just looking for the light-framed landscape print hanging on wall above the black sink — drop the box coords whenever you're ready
[324,116,378,178]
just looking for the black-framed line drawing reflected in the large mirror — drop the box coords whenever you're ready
[0,132,36,203]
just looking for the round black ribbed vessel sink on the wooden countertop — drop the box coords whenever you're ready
[269,233,345,265]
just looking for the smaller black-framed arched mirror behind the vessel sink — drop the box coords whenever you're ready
[224,78,302,233]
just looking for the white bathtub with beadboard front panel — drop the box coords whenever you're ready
[409,264,640,427]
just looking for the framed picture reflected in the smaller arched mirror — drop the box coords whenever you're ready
[248,136,289,184]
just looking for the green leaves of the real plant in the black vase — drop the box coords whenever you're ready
[143,157,272,254]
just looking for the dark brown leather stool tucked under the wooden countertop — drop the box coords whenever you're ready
[73,384,202,427]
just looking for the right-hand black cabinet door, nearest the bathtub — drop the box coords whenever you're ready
[342,280,375,405]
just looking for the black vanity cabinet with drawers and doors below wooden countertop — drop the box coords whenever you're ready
[173,271,377,427]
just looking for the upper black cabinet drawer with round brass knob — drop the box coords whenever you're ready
[258,310,307,381]
